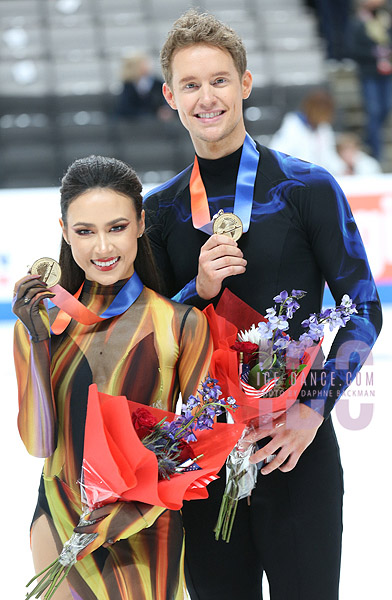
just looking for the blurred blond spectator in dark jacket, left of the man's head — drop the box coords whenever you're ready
[116,54,172,120]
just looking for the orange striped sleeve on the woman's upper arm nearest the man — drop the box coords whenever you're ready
[178,308,213,399]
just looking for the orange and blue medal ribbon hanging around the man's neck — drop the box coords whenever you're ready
[189,134,259,235]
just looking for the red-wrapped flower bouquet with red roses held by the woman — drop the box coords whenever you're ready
[26,377,244,600]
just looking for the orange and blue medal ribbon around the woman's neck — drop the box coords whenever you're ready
[49,271,143,335]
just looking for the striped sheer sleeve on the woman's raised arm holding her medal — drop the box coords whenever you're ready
[14,320,57,457]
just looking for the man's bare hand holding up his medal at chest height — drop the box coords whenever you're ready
[196,234,247,300]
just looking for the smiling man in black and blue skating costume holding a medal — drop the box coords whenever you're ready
[145,11,381,600]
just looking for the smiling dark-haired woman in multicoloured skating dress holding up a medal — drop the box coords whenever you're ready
[14,156,211,600]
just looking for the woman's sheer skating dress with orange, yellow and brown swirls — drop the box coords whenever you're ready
[15,281,212,600]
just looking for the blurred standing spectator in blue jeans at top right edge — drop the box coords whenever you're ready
[349,0,392,159]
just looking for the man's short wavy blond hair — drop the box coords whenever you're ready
[161,9,246,87]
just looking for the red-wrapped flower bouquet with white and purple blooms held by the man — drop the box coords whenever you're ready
[205,290,356,542]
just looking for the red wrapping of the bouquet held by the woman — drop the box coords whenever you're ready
[82,384,244,510]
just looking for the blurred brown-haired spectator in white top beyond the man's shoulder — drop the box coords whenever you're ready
[269,89,343,175]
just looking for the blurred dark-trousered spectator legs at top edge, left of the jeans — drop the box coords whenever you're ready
[306,0,352,60]
